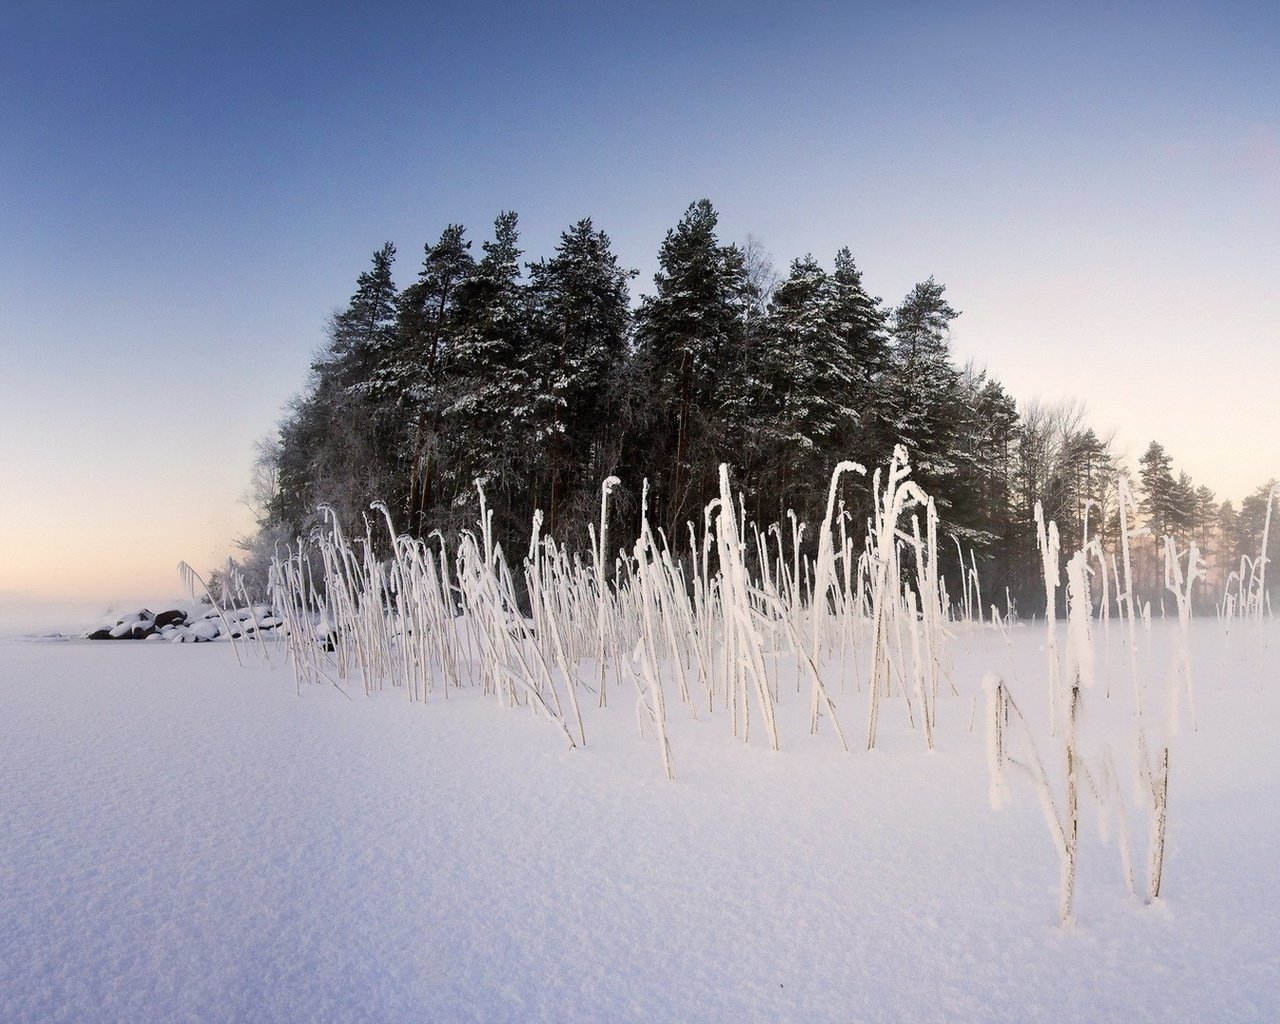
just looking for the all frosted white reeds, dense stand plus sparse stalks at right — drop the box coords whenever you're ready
[241,448,1239,922]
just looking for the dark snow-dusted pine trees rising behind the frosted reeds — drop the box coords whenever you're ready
[241,200,1280,613]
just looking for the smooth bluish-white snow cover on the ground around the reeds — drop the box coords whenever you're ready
[0,622,1280,1024]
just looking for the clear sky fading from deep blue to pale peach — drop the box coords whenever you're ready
[0,0,1280,604]
